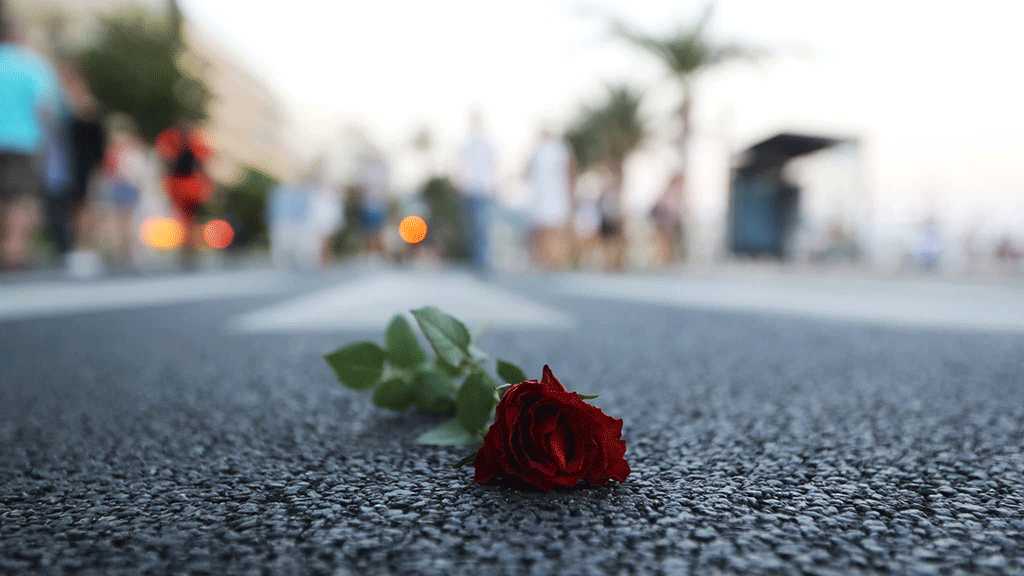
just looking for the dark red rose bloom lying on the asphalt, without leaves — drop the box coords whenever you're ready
[474,366,630,491]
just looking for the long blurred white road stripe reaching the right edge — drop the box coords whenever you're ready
[558,273,1024,332]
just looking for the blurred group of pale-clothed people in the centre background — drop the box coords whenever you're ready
[258,113,683,273]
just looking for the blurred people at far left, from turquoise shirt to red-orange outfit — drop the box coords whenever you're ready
[0,10,214,277]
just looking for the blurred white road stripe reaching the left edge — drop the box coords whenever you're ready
[0,271,287,321]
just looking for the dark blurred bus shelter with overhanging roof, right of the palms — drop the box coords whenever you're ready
[728,132,846,258]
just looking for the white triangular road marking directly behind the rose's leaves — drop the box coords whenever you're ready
[229,272,572,332]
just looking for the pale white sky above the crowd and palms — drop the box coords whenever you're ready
[183,0,1024,234]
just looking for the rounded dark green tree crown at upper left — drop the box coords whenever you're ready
[78,8,209,140]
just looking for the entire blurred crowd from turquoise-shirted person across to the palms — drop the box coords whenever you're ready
[0,0,683,277]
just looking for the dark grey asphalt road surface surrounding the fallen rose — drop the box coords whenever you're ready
[0,270,1024,575]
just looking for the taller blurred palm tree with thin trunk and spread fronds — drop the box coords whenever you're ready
[615,4,751,172]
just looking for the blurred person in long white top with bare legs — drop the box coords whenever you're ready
[527,129,574,269]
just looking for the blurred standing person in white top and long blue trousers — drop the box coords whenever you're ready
[456,113,498,272]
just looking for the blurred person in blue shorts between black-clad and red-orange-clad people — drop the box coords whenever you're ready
[103,117,148,265]
